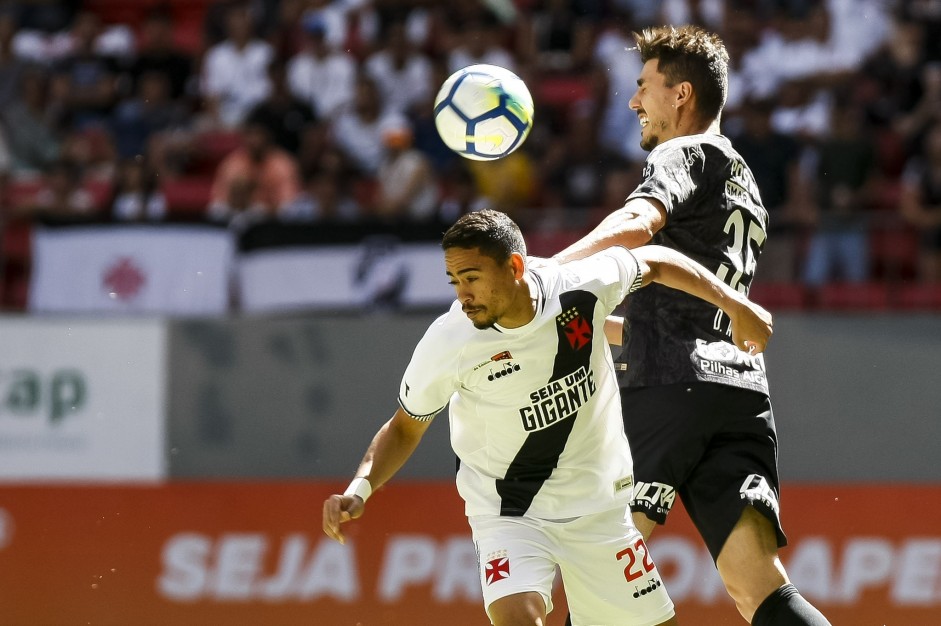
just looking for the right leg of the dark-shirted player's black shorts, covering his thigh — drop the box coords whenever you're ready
[680,385,787,559]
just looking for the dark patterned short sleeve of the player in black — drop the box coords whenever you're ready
[627,145,705,215]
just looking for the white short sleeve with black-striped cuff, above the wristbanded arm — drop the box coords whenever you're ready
[399,315,460,422]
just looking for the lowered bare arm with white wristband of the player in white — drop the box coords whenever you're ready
[323,408,431,543]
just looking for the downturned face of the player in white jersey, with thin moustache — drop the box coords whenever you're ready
[444,248,528,330]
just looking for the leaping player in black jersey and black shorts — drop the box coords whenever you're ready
[555,26,829,626]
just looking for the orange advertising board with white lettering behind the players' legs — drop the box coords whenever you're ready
[0,481,941,626]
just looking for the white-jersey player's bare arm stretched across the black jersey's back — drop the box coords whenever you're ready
[632,246,772,354]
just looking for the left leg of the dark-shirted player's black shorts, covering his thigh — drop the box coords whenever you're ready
[621,383,716,534]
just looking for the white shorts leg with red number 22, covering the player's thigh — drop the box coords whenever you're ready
[558,509,674,626]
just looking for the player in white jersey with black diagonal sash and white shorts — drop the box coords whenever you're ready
[323,210,771,626]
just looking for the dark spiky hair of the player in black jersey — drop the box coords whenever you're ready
[634,26,729,120]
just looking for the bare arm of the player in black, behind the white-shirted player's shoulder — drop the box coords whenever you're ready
[552,198,667,263]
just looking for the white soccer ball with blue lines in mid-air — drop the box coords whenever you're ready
[435,65,533,161]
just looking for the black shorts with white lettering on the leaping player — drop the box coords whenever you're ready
[621,383,787,560]
